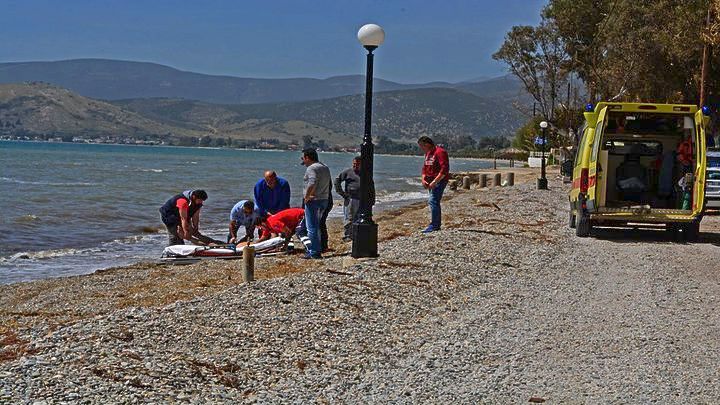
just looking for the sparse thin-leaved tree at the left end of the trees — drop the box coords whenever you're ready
[493,19,569,121]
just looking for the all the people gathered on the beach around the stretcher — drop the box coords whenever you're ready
[160,136,449,259]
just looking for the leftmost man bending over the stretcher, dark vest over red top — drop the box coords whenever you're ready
[160,190,218,246]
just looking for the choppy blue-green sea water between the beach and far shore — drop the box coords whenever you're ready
[0,141,506,284]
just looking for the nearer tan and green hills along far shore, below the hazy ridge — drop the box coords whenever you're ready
[0,83,524,147]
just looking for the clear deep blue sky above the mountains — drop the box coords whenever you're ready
[0,0,546,83]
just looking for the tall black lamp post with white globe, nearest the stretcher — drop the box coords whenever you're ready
[351,24,385,258]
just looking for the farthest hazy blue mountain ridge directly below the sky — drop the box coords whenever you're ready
[0,59,520,104]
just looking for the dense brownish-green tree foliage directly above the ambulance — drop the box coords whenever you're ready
[543,0,720,103]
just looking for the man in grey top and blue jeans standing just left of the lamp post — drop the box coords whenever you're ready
[302,149,332,259]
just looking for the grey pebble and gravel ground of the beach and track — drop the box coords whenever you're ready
[0,169,720,403]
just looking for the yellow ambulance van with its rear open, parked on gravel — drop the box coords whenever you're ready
[569,102,710,240]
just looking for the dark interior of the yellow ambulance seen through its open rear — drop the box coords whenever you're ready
[598,112,696,209]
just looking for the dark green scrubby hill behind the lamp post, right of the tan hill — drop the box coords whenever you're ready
[113,88,524,143]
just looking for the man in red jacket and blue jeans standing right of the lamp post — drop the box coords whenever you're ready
[418,136,450,233]
